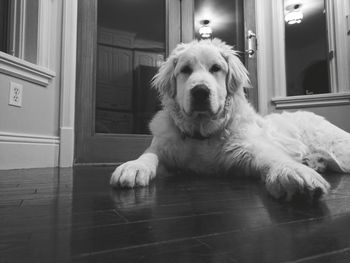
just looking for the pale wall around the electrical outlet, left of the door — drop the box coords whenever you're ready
[0,0,63,169]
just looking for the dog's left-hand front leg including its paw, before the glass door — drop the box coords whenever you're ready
[110,138,159,188]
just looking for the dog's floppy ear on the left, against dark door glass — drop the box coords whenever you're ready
[152,44,186,98]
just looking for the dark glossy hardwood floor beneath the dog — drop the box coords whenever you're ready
[0,167,350,263]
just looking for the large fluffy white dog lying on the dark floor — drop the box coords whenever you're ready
[110,39,350,200]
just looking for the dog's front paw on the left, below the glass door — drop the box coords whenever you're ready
[110,160,155,188]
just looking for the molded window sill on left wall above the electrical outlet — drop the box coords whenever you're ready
[0,52,55,87]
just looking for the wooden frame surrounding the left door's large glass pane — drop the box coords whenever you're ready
[74,0,181,165]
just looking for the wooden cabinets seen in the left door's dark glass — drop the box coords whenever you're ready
[95,28,164,133]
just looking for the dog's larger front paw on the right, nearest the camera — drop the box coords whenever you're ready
[265,163,330,201]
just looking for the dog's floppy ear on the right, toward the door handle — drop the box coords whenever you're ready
[212,39,251,94]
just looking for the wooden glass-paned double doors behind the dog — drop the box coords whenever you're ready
[75,0,257,164]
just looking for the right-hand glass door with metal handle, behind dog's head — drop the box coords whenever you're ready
[187,0,258,109]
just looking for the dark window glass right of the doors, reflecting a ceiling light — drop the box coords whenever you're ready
[284,0,333,96]
